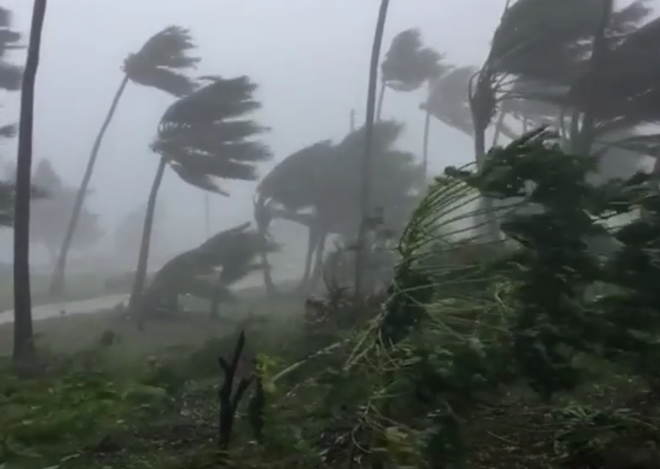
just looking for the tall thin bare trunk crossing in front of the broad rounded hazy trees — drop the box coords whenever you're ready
[355,0,390,299]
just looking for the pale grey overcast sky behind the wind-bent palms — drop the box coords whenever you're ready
[0,0,504,262]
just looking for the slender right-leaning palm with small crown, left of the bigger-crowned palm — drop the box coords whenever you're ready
[50,26,199,295]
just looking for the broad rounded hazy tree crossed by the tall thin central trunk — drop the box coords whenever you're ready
[255,121,424,293]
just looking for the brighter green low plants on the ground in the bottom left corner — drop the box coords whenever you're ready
[0,351,169,463]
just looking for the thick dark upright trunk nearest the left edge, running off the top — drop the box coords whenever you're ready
[12,0,47,366]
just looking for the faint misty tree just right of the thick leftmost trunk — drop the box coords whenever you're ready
[30,160,104,265]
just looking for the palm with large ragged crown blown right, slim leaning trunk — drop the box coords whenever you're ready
[130,76,271,326]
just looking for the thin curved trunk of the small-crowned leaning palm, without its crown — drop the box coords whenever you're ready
[50,75,129,295]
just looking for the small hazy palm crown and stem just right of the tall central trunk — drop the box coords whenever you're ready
[376,28,444,120]
